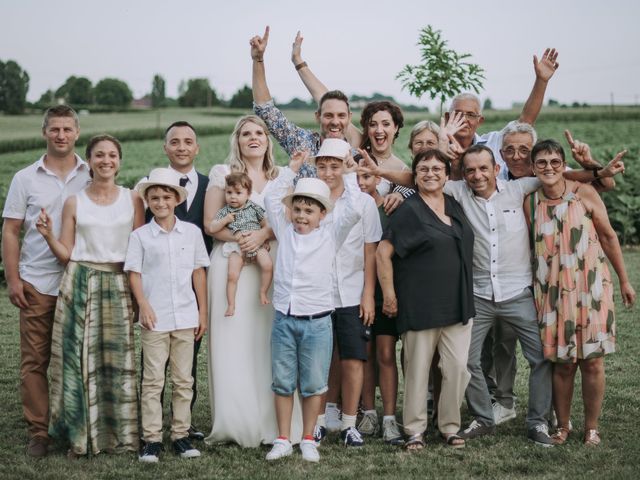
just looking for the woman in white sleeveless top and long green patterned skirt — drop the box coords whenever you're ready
[37,135,144,457]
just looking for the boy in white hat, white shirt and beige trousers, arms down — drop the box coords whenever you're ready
[124,168,209,463]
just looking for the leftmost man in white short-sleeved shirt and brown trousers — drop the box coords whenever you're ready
[2,105,89,457]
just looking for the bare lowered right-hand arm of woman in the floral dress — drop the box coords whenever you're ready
[579,185,636,307]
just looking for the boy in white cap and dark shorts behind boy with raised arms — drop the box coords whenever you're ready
[315,138,382,447]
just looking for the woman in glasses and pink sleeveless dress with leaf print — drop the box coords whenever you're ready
[524,140,636,446]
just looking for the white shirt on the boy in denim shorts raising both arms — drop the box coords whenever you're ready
[265,168,361,315]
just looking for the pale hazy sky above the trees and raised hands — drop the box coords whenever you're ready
[0,0,640,108]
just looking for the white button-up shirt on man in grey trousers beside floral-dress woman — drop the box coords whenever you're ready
[444,177,540,302]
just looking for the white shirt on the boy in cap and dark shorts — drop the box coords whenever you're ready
[324,173,382,308]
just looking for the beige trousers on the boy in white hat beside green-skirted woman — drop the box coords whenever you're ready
[140,328,195,443]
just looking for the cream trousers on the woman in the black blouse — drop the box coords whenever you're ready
[402,320,473,435]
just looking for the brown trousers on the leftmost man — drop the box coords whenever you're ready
[20,282,58,437]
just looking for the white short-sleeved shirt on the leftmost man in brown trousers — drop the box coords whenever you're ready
[2,155,91,295]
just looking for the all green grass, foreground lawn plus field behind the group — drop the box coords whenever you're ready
[0,109,640,480]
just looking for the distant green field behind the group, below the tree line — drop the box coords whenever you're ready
[0,109,640,194]
